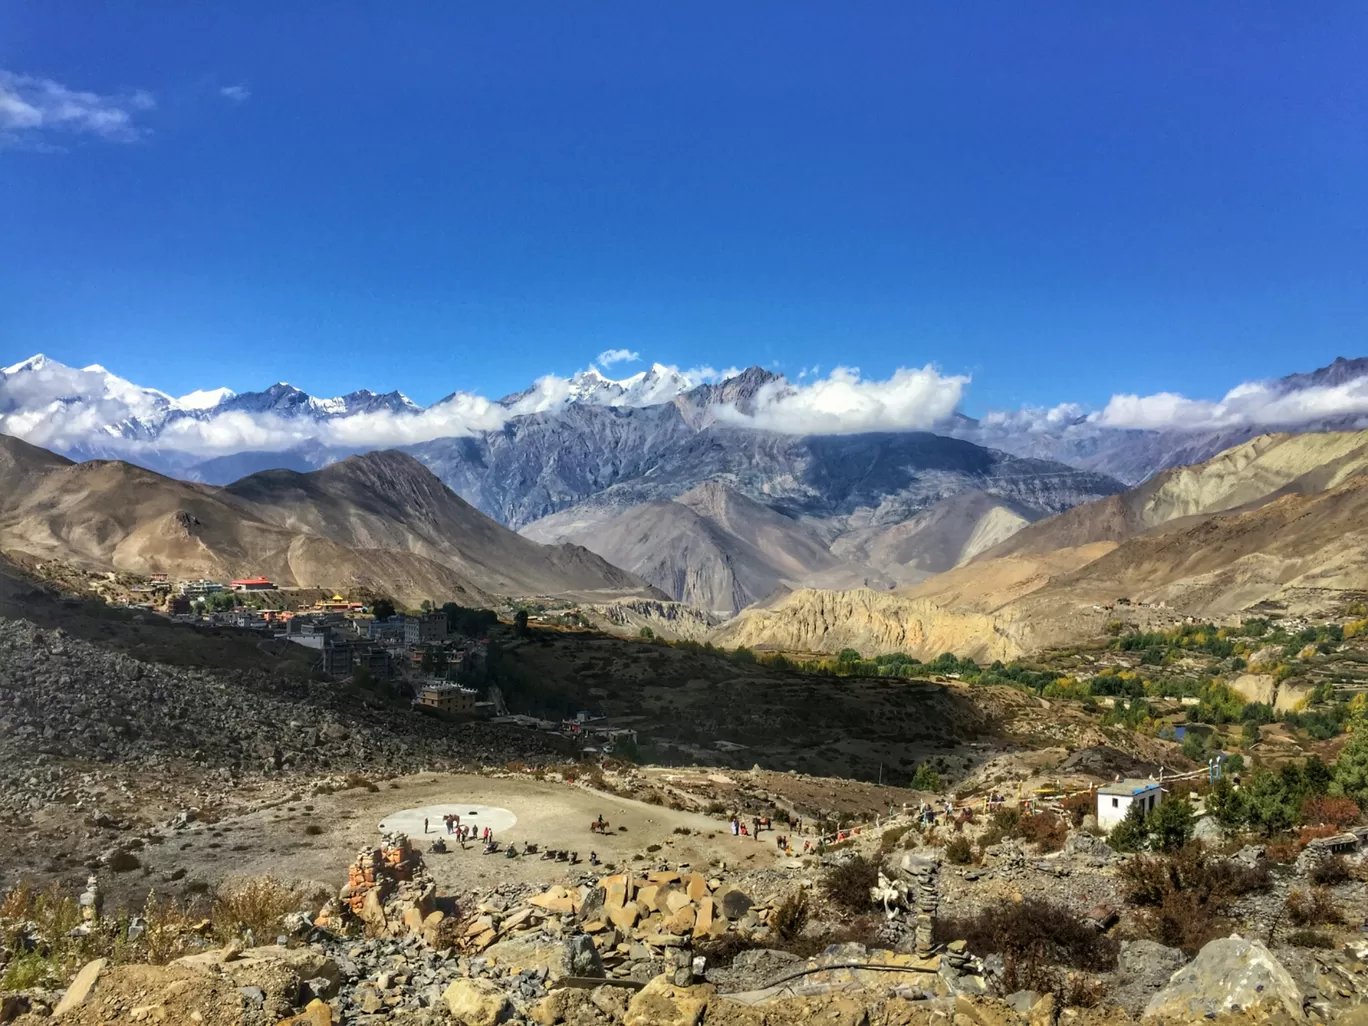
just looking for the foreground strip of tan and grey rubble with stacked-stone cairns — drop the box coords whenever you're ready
[8,836,1368,1026]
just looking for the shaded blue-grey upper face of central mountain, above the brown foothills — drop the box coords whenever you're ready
[418,404,1122,528]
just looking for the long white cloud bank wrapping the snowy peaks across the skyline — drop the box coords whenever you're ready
[0,350,1368,457]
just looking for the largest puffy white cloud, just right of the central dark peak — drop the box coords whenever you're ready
[717,365,969,435]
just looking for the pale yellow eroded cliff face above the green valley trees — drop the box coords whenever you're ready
[713,588,1031,662]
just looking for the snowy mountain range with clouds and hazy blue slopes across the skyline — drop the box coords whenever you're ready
[0,354,1368,484]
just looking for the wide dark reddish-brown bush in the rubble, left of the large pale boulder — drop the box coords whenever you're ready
[934,897,1119,1004]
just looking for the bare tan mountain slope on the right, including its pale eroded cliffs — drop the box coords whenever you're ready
[717,432,1368,658]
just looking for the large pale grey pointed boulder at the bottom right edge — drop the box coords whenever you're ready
[1145,934,1302,1023]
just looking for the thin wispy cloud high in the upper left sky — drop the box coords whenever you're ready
[0,70,156,152]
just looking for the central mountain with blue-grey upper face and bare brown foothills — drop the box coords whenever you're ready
[503,429,1120,616]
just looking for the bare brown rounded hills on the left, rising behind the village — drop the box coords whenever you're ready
[0,435,658,603]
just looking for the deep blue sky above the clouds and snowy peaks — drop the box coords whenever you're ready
[0,0,1368,412]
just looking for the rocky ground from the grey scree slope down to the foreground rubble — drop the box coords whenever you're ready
[8,610,1368,1026]
